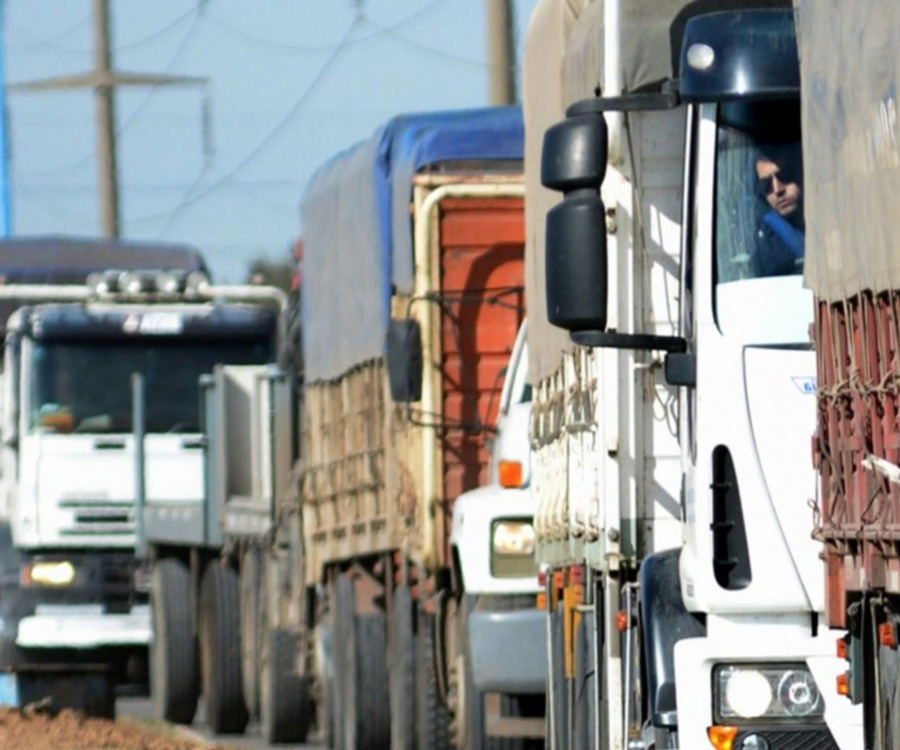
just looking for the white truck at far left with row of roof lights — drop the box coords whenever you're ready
[0,237,276,715]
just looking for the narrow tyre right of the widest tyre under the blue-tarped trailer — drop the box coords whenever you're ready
[388,585,418,750]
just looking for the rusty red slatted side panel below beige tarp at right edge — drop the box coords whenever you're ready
[814,292,900,627]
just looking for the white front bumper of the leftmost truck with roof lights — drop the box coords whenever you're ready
[16,604,151,649]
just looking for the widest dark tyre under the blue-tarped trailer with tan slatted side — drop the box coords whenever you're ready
[340,613,391,750]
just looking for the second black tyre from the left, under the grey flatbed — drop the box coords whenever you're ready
[200,562,249,734]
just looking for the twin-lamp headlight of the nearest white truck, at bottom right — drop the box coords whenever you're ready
[713,664,825,723]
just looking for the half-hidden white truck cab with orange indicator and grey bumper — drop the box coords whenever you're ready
[436,324,547,750]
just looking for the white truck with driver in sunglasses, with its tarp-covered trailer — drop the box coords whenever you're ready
[523,0,862,750]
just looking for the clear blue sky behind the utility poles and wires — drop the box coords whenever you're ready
[0,0,536,282]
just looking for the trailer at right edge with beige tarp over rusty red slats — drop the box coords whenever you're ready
[795,2,900,748]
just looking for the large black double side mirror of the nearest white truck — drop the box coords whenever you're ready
[541,112,609,331]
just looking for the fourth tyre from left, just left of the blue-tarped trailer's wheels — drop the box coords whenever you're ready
[259,628,312,745]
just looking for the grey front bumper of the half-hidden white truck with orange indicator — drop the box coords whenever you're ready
[469,596,547,695]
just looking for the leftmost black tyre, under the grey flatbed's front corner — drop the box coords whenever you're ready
[150,558,200,724]
